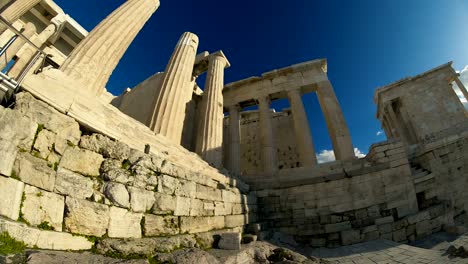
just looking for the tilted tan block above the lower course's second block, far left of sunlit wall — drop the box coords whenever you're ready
[14,152,55,191]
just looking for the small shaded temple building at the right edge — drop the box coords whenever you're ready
[374,62,468,144]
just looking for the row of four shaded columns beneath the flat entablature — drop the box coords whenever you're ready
[228,82,355,174]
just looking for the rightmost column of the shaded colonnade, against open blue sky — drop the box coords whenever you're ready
[317,81,356,160]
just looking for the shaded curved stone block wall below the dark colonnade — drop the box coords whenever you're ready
[255,142,452,247]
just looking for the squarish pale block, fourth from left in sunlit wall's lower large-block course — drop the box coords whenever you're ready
[109,206,143,238]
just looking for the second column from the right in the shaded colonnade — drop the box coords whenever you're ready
[288,89,317,167]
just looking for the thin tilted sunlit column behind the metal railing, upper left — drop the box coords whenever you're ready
[8,15,66,78]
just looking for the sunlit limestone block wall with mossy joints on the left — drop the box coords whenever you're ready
[0,93,256,253]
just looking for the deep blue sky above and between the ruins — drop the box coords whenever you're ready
[55,0,468,159]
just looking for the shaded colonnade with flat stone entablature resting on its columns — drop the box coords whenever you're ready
[223,59,355,176]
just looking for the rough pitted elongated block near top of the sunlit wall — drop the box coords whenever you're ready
[80,134,130,161]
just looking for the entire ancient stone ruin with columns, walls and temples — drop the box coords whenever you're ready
[0,0,468,263]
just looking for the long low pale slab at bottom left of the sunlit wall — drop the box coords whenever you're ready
[0,219,93,250]
